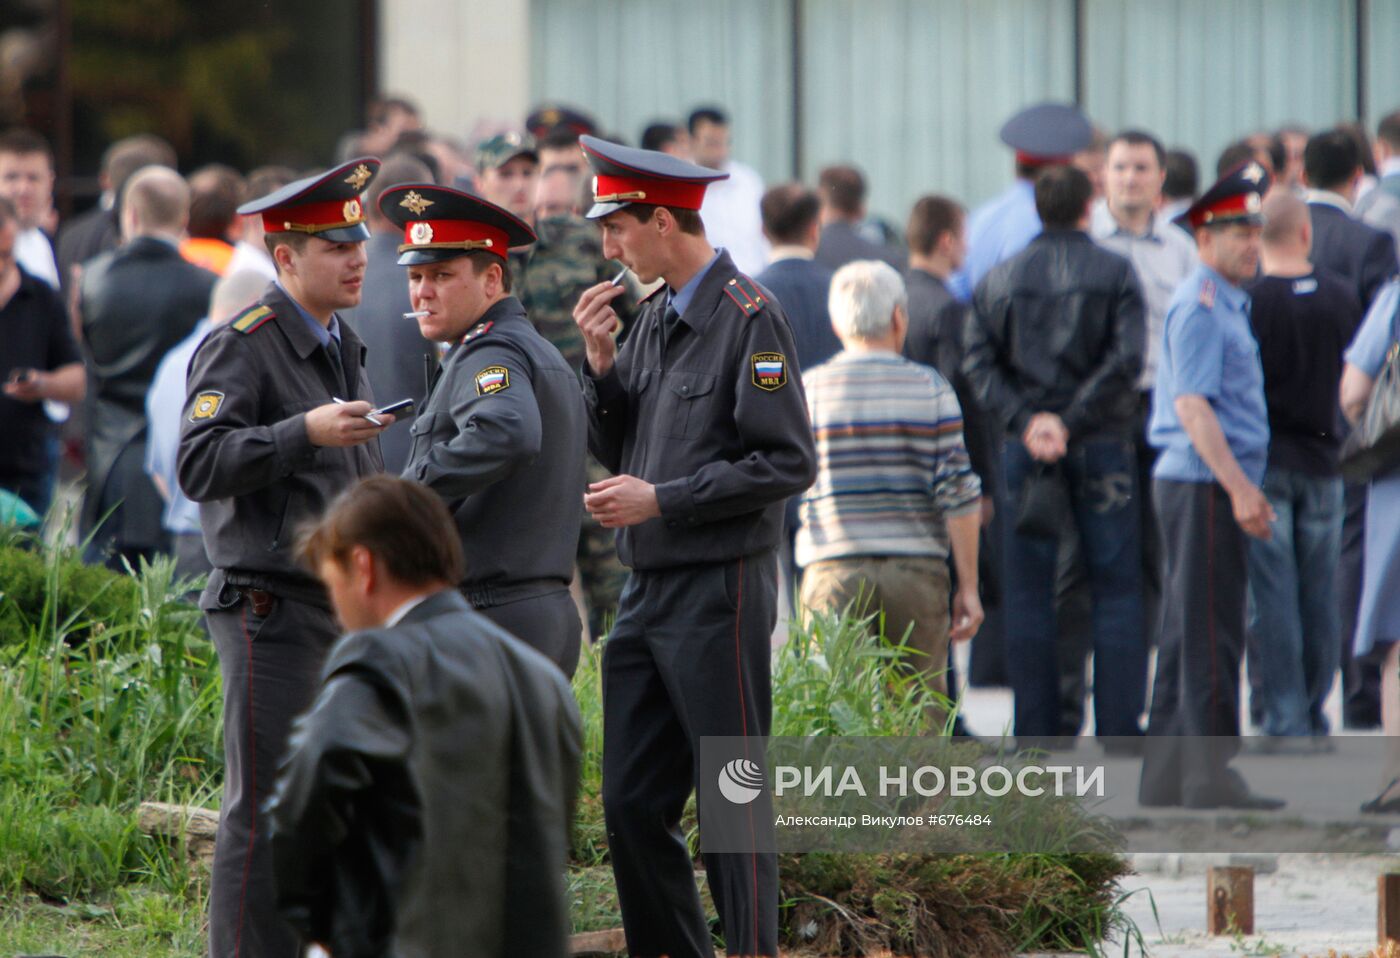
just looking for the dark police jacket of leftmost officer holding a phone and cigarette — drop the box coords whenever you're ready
[176,283,383,608]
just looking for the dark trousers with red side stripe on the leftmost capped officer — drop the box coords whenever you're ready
[200,571,340,958]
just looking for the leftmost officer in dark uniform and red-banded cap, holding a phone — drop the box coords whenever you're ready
[176,158,393,958]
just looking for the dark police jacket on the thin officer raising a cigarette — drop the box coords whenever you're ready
[584,252,816,570]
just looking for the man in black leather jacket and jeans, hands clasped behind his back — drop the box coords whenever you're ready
[963,167,1147,740]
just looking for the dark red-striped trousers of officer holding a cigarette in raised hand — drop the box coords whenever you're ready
[603,550,778,958]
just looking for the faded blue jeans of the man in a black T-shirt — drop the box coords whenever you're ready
[1249,466,1343,735]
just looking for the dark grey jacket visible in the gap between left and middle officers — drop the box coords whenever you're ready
[340,232,437,475]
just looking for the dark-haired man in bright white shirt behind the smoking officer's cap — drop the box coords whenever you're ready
[689,106,769,276]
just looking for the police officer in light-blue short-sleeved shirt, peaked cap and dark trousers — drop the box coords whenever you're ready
[1138,161,1284,811]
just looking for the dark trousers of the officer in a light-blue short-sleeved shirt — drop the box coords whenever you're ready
[1138,479,1249,807]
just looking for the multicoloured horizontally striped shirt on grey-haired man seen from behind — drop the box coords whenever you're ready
[797,352,981,566]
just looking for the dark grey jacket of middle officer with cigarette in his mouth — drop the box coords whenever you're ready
[403,296,588,593]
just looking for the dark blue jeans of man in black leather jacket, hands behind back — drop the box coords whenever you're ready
[1001,438,1147,737]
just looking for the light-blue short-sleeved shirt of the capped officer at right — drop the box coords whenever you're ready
[1148,265,1268,485]
